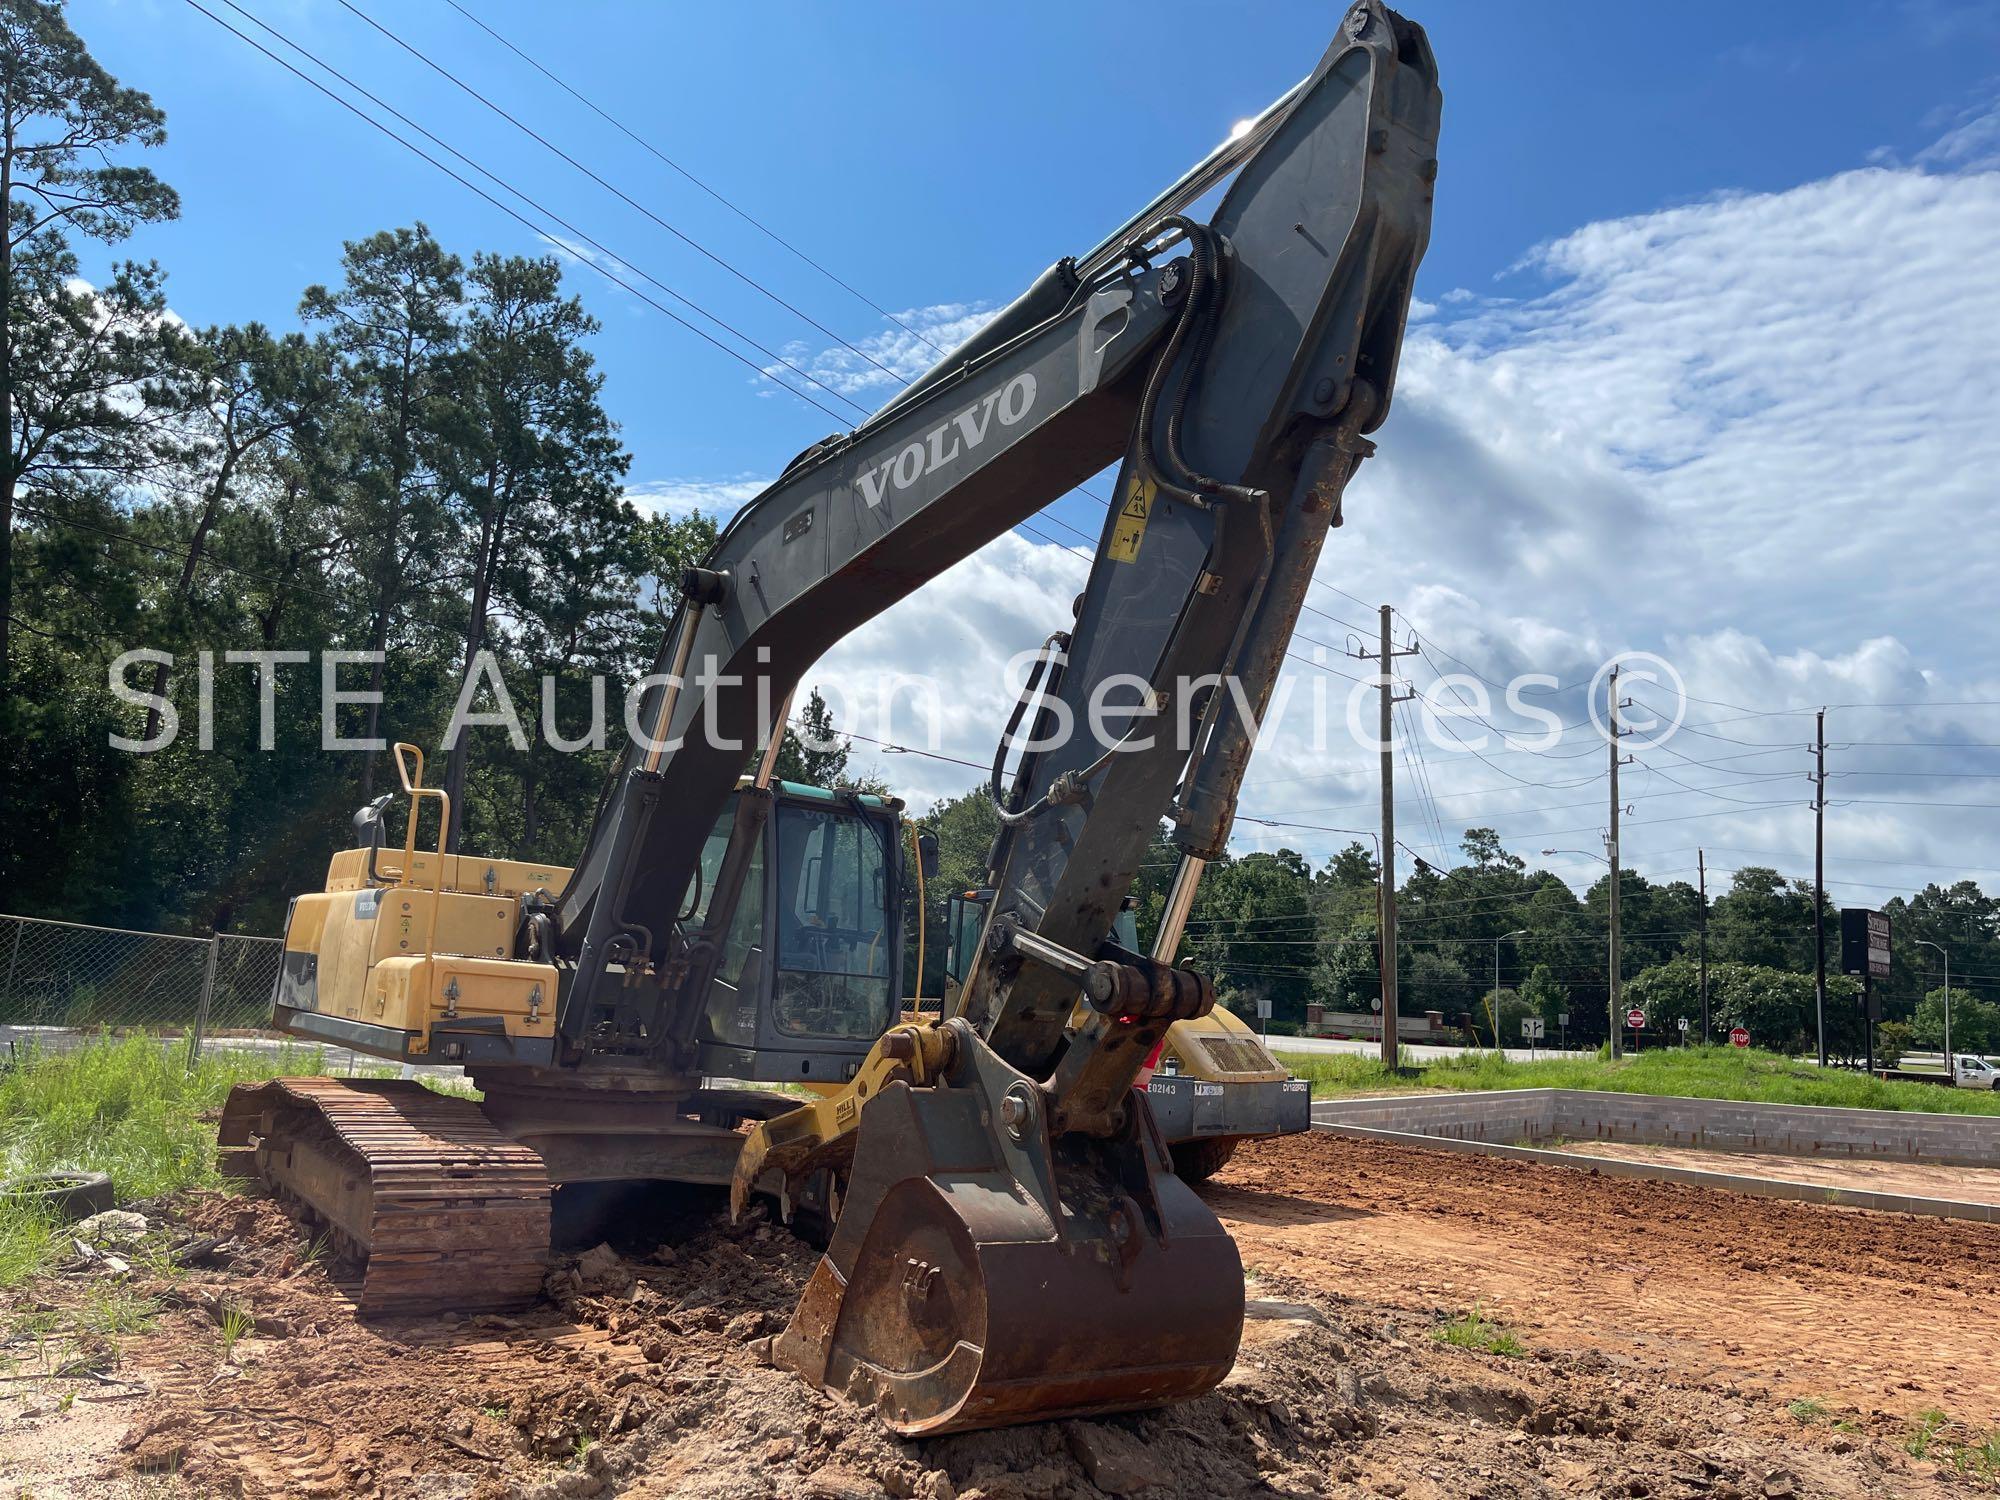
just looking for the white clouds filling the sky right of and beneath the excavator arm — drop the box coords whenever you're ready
[662,106,2000,904]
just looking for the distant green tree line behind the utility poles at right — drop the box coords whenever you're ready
[920,788,2000,1060]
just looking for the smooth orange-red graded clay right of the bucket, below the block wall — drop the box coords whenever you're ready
[1208,1134,2000,1428]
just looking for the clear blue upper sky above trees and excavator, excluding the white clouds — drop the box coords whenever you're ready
[86,0,2000,500]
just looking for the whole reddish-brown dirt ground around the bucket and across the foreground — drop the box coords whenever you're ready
[0,1136,2000,1500]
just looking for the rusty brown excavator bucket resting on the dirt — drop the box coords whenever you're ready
[772,1032,1244,1436]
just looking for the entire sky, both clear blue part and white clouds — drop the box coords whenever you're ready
[72,0,2000,902]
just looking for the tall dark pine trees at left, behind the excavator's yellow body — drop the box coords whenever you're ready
[0,0,714,932]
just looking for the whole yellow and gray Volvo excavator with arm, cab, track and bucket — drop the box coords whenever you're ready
[222,0,1440,1434]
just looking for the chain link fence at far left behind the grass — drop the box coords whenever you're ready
[0,914,284,1062]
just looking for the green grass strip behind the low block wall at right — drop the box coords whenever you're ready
[1278,1046,2000,1114]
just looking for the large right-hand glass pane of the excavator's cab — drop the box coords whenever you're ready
[772,806,896,1038]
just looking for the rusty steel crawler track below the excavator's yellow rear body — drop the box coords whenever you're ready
[218,1078,550,1316]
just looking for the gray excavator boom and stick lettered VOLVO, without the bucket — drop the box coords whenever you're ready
[544,0,1438,1132]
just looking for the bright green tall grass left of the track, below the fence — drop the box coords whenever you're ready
[0,1034,336,1286]
